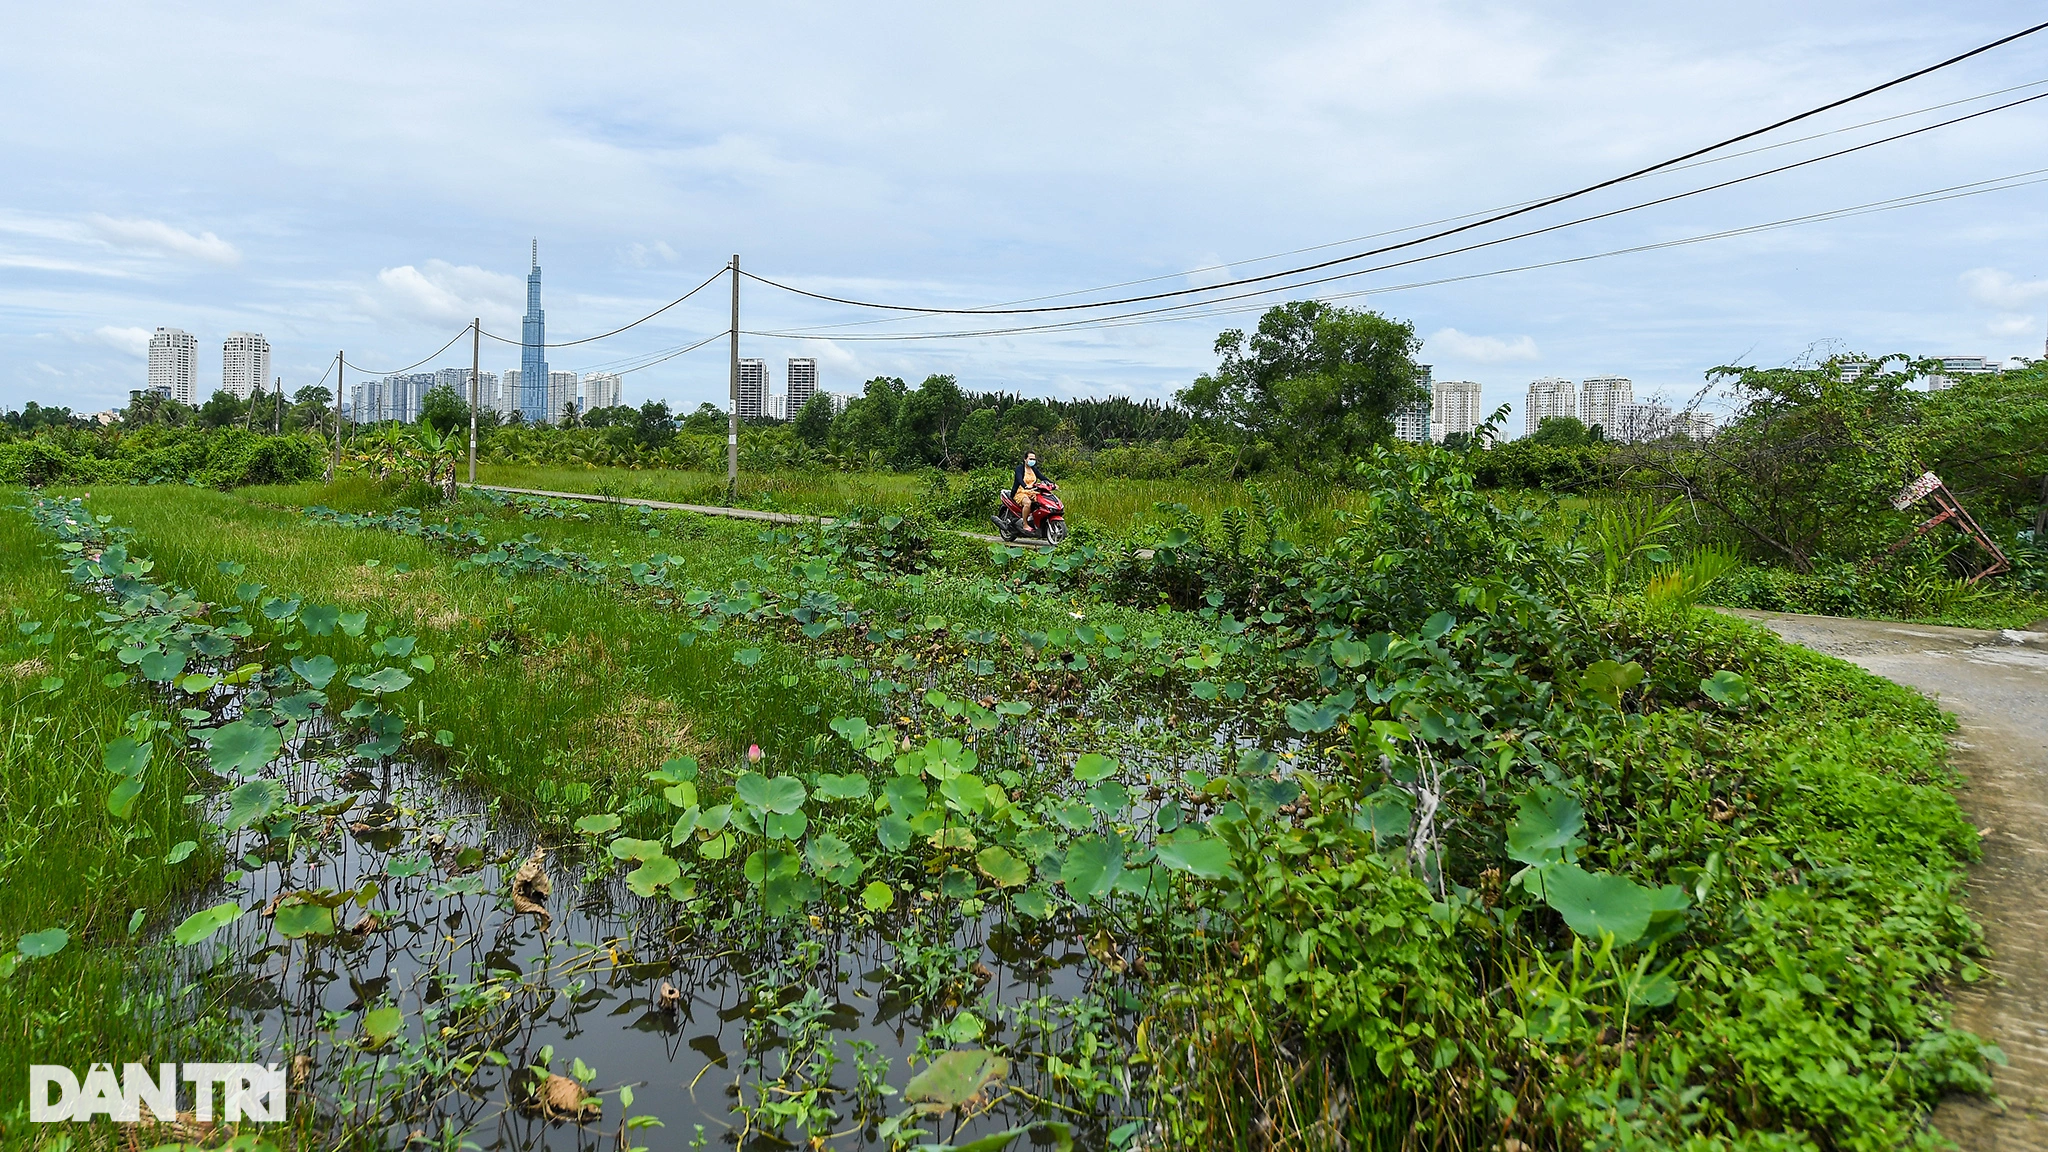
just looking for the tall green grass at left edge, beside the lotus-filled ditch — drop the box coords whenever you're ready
[0,492,231,1105]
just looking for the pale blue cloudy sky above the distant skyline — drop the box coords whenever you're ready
[0,0,2048,430]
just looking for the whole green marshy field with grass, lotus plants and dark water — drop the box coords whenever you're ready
[0,453,1989,1148]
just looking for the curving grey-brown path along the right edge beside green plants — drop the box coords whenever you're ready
[1737,613,2048,1152]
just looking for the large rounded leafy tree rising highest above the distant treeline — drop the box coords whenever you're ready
[1176,299,1425,471]
